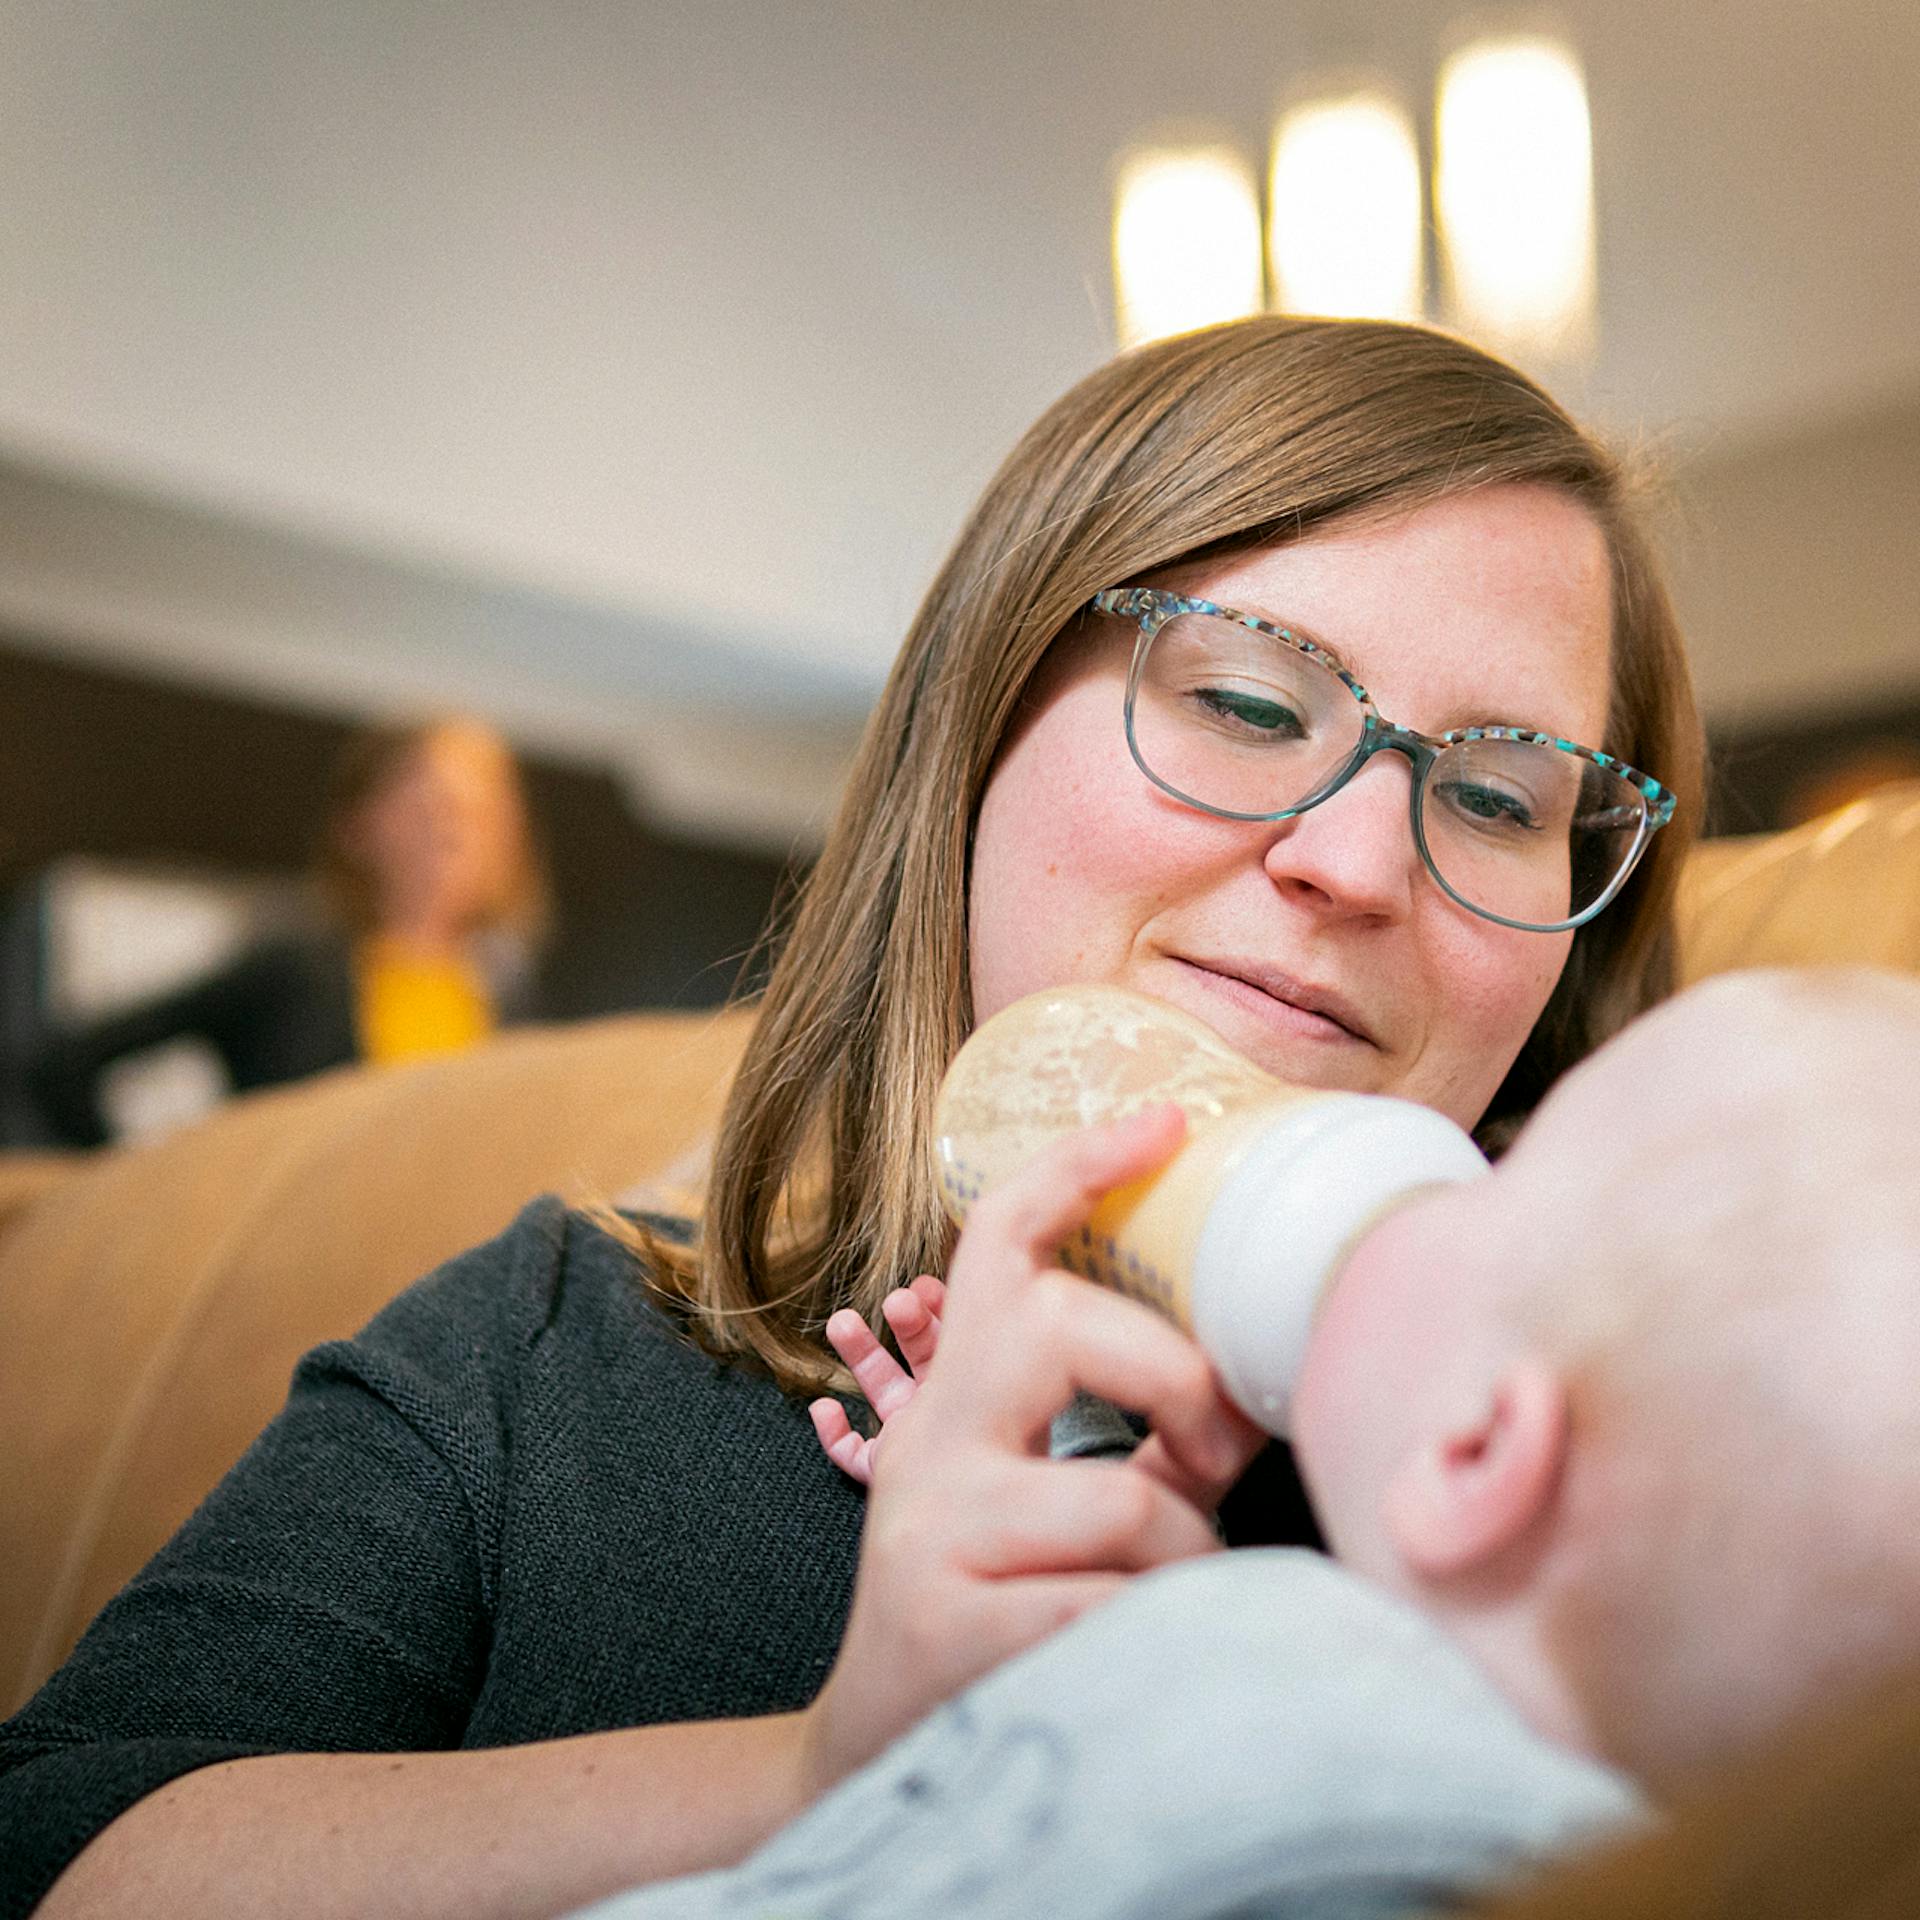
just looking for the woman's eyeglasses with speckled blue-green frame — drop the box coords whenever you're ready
[1092,588,1674,933]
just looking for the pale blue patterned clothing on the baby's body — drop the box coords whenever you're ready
[568,1548,1644,1920]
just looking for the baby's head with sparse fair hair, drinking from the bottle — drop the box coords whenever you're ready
[1294,972,1920,1788]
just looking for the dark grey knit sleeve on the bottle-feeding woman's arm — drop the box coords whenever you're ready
[0,1202,564,1920]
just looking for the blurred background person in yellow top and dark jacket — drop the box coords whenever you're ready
[33,718,547,1146]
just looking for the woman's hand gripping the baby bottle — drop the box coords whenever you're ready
[803,1106,1265,1791]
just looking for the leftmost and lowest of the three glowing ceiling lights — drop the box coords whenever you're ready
[1114,146,1265,348]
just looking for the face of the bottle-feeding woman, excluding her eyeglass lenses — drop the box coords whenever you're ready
[968,486,1611,1127]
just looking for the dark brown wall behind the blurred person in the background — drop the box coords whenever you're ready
[0,637,787,1018]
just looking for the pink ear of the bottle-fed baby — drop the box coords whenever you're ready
[1380,1357,1567,1580]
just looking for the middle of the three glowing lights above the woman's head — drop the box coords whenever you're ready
[1267,88,1425,321]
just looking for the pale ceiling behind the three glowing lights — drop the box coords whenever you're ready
[0,0,1920,837]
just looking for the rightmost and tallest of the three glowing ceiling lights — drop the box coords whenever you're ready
[1434,38,1596,357]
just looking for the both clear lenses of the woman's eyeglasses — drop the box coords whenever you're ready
[1131,614,1645,927]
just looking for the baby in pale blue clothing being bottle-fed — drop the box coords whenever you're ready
[576,972,1920,1920]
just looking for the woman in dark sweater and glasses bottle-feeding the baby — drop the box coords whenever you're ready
[0,319,1699,1916]
